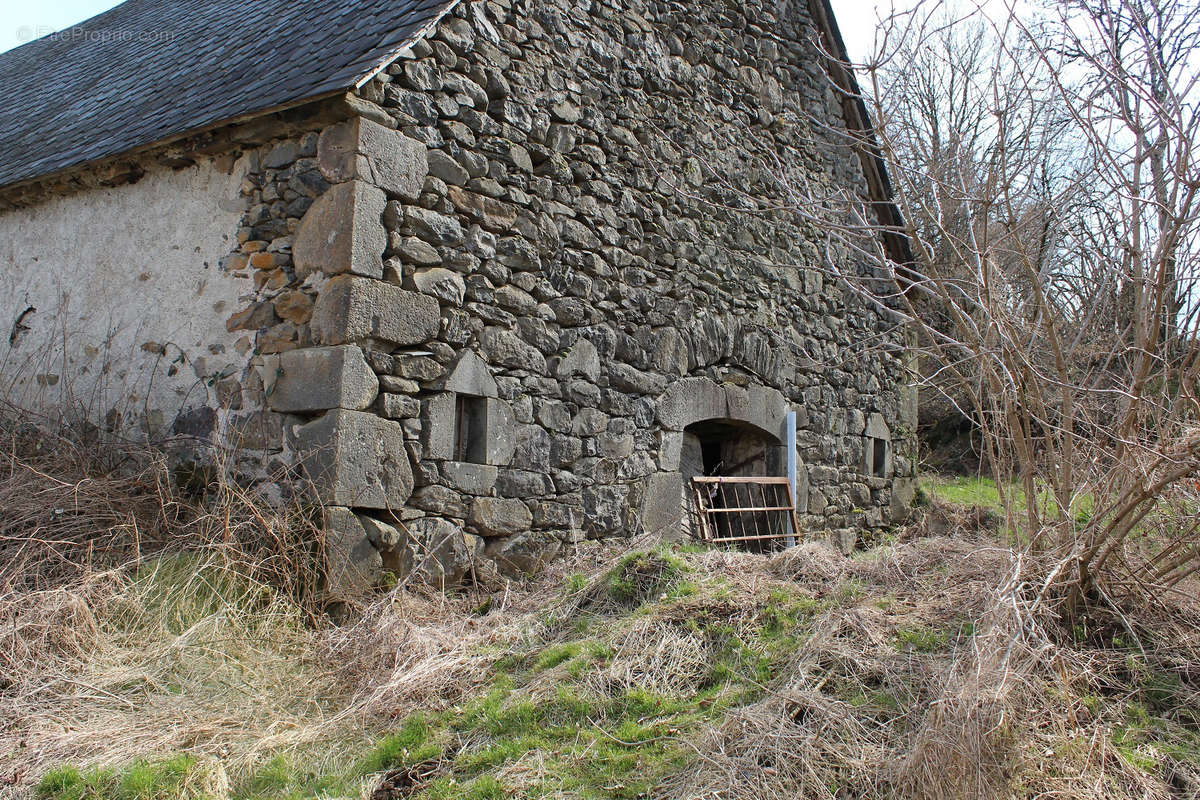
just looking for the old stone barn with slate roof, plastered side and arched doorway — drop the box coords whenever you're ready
[0,0,916,595]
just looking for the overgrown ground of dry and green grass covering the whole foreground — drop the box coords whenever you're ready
[16,410,1200,800]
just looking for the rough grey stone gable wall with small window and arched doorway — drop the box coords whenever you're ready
[278,0,913,592]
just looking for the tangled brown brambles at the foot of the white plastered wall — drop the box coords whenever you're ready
[0,407,322,599]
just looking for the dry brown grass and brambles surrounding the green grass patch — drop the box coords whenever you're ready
[0,410,1200,800]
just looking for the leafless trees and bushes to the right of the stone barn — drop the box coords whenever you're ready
[799,0,1200,621]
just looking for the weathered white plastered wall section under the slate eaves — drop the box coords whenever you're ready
[0,153,250,437]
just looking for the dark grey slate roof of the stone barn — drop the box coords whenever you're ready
[0,0,455,186]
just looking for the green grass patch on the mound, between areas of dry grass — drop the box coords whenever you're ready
[30,549,857,800]
